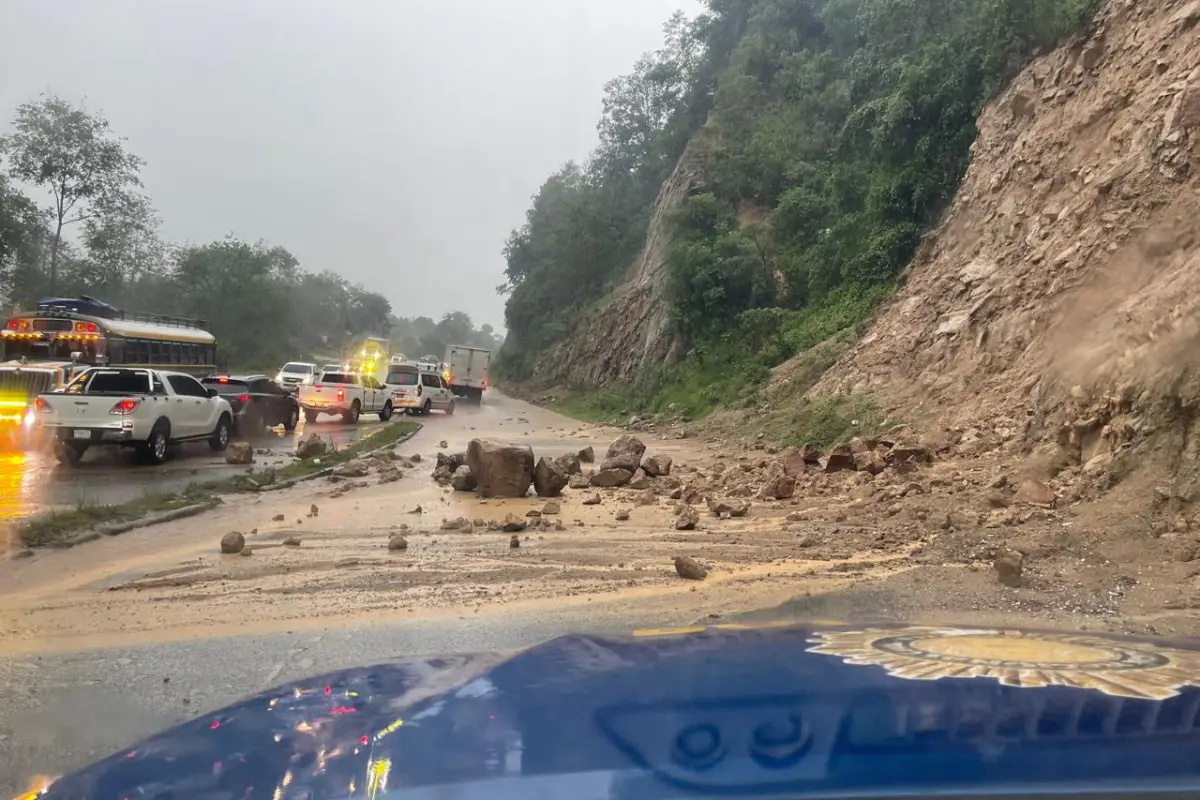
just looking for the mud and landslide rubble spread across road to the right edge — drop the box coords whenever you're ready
[0,397,1196,655]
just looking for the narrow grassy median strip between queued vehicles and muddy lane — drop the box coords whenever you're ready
[17,420,421,547]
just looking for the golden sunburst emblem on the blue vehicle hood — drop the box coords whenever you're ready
[808,627,1200,700]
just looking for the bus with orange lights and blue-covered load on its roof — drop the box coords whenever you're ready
[0,295,217,377]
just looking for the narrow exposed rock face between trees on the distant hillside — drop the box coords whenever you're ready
[534,133,704,386]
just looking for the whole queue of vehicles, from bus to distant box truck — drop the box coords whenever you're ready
[0,296,491,463]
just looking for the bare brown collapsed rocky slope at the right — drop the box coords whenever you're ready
[812,0,1200,470]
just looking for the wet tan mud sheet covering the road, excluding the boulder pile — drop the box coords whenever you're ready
[0,398,902,652]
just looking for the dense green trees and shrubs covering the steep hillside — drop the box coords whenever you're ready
[500,0,1102,413]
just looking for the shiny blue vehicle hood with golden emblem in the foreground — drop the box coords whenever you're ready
[30,625,1200,800]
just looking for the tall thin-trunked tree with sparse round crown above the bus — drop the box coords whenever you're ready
[0,96,142,293]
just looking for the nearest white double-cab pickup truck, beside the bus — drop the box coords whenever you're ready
[34,367,233,464]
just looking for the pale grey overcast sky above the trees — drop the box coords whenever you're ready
[0,0,695,327]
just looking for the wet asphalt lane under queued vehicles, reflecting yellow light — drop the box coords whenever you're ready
[0,416,380,523]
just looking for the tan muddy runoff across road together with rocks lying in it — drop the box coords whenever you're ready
[0,407,908,652]
